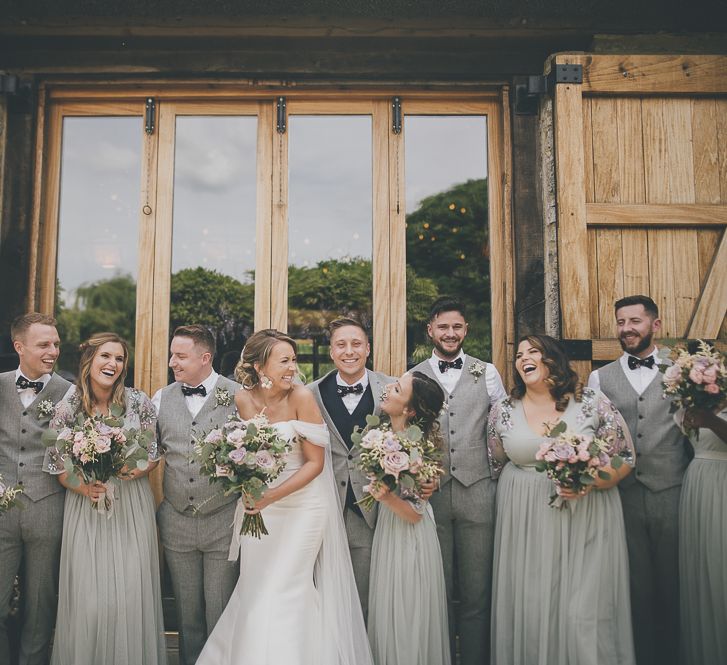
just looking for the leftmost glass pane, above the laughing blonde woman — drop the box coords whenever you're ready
[56,117,143,385]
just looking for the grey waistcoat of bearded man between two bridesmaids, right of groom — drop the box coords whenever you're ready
[414,355,490,487]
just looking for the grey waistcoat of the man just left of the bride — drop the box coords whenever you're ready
[157,376,240,515]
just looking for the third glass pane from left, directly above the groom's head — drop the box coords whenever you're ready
[288,116,373,380]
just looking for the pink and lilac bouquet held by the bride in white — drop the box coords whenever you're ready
[194,413,291,538]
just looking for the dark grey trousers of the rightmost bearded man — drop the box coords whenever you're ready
[619,483,682,665]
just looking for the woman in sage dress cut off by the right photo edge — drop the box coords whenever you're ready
[675,396,727,665]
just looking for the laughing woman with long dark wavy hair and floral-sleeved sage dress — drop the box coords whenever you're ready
[488,335,635,665]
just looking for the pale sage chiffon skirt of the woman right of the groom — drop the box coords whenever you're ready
[368,504,450,665]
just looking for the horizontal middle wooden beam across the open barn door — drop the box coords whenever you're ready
[586,203,727,226]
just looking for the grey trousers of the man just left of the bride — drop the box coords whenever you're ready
[157,499,240,665]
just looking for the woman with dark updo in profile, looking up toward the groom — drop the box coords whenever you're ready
[368,372,450,665]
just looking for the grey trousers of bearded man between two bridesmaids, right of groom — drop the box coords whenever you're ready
[429,478,497,665]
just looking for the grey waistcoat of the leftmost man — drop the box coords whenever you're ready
[0,371,71,501]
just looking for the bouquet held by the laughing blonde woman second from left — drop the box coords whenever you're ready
[42,405,153,510]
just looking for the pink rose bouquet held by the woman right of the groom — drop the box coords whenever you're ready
[351,415,444,510]
